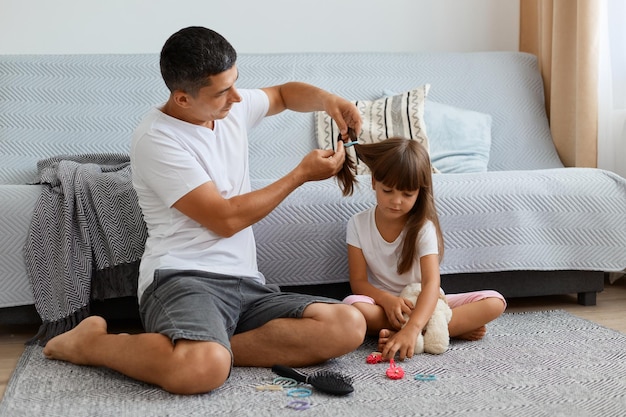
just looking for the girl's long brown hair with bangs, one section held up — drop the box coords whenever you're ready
[337,137,444,274]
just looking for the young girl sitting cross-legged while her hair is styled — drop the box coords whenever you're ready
[338,138,506,360]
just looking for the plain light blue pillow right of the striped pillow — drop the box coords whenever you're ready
[424,101,491,173]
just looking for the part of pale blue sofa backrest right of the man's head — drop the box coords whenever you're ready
[238,52,563,178]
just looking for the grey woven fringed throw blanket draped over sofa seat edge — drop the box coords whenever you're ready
[24,154,147,345]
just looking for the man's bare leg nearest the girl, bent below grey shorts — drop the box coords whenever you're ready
[231,303,366,367]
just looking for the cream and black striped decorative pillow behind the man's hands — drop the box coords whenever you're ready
[315,84,430,175]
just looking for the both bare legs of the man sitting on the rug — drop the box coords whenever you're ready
[44,303,365,394]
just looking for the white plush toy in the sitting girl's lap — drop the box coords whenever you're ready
[400,283,452,355]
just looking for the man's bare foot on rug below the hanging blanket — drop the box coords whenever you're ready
[43,316,107,365]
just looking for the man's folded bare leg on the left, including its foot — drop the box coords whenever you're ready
[44,316,231,394]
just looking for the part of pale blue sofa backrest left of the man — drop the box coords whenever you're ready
[0,54,167,184]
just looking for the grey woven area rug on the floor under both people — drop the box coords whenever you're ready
[0,311,626,417]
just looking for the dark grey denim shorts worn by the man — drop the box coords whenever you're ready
[139,269,341,353]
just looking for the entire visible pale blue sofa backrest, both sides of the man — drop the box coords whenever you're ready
[0,52,562,184]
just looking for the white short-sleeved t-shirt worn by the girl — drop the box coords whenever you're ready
[346,206,439,295]
